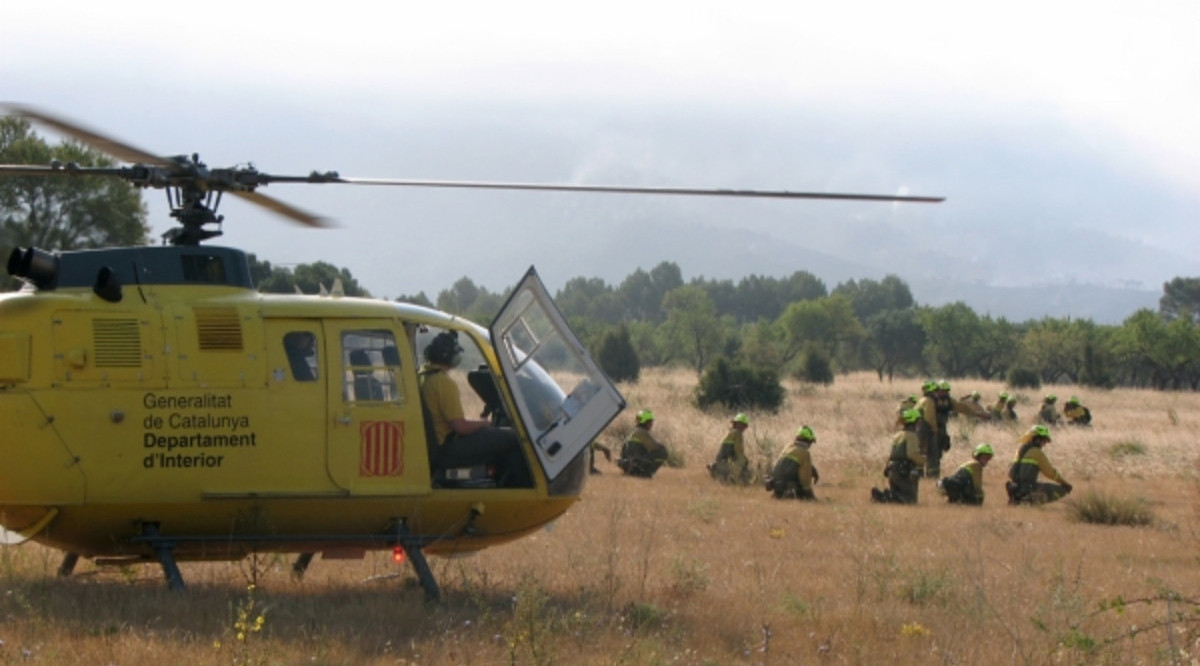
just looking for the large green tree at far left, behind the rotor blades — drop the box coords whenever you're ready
[0,116,150,266]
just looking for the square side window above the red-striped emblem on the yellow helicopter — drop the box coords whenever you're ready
[342,330,403,402]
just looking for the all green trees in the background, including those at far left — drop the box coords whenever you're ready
[0,118,1200,390]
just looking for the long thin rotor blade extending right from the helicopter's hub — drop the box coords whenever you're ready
[328,175,946,204]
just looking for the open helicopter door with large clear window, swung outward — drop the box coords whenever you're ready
[490,266,625,481]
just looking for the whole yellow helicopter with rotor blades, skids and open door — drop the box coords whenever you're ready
[0,103,943,600]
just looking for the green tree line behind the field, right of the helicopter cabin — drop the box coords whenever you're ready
[417,262,1200,390]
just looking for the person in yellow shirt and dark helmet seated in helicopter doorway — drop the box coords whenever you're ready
[418,331,533,487]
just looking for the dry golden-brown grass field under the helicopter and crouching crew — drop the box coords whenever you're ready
[0,371,1200,665]
